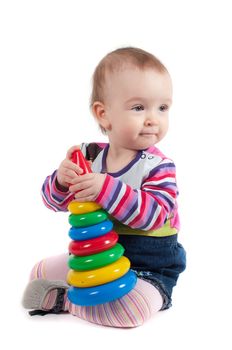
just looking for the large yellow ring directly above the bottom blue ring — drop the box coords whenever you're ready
[67,256,130,288]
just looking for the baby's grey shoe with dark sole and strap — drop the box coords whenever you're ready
[22,279,69,316]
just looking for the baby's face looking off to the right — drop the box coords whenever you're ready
[100,67,172,150]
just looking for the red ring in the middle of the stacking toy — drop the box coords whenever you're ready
[69,231,118,256]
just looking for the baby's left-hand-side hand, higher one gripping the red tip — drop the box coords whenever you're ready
[56,146,83,190]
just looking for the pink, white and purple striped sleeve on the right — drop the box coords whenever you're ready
[96,159,178,231]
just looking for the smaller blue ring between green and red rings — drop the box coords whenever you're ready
[69,220,113,241]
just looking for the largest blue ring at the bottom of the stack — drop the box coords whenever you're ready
[68,270,137,306]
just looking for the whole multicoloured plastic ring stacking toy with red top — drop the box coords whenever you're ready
[67,150,137,306]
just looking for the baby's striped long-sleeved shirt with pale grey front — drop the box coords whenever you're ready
[42,143,179,236]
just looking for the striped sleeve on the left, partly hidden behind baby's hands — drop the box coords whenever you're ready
[41,171,74,211]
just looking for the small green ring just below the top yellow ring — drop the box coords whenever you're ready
[69,210,108,227]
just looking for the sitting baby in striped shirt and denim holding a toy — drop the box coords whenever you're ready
[23,47,186,327]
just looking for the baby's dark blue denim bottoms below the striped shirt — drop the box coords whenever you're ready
[118,235,186,310]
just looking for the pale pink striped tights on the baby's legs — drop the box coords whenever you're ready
[25,254,163,327]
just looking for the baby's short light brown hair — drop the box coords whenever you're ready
[90,47,168,134]
